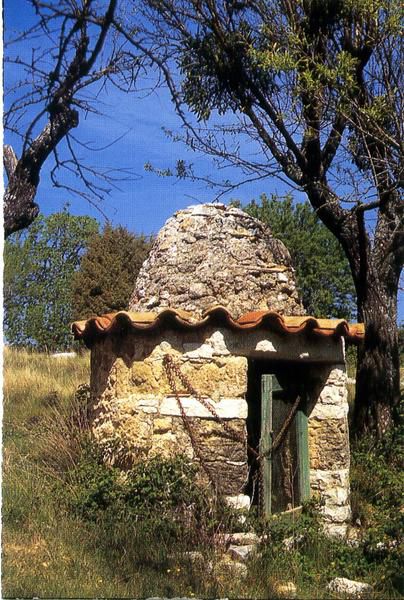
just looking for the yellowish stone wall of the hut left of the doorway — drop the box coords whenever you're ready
[92,332,248,496]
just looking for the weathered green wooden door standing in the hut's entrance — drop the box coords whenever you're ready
[260,374,310,516]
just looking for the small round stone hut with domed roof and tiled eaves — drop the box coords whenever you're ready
[73,204,364,535]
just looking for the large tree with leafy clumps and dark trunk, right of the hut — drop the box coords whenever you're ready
[125,0,404,436]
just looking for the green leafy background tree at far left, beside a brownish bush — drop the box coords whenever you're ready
[4,210,98,351]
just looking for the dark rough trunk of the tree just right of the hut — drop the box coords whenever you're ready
[353,282,400,439]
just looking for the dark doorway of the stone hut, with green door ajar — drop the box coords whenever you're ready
[247,359,309,515]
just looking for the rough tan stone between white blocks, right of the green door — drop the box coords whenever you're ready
[309,418,349,470]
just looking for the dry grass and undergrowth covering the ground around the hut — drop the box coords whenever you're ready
[2,349,402,599]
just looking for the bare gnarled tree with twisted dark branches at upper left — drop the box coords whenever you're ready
[4,0,140,237]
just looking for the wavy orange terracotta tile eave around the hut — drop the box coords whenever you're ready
[72,306,365,346]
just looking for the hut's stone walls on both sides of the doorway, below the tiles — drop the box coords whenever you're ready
[88,329,350,535]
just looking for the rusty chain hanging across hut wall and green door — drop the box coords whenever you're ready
[163,354,301,511]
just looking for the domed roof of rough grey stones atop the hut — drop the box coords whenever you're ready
[129,203,304,318]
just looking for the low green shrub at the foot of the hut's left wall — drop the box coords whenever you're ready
[65,450,207,537]
